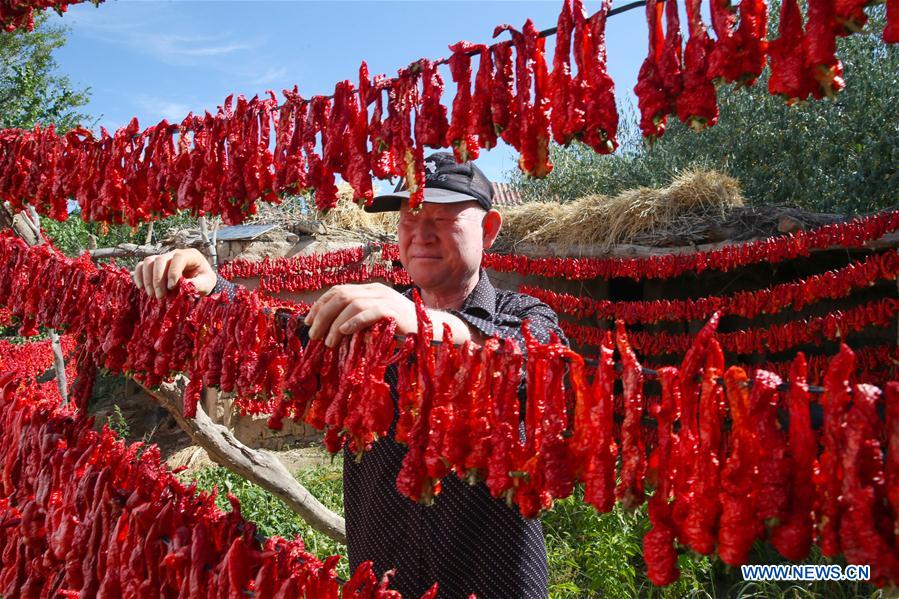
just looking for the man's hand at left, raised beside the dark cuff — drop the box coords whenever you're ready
[131,249,216,299]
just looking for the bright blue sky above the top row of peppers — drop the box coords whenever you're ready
[52,0,646,181]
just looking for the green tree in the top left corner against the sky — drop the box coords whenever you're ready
[0,14,89,131]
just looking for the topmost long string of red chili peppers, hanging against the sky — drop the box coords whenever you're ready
[0,0,899,226]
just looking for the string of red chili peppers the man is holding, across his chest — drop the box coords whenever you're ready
[0,235,899,584]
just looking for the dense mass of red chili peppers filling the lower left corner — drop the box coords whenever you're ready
[0,372,412,599]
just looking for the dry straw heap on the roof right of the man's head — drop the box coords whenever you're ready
[500,171,743,248]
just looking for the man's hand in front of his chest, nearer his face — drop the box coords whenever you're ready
[304,283,418,347]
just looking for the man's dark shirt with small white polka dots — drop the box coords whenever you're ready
[217,269,567,599]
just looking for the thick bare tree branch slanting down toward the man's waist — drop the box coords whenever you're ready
[135,376,346,543]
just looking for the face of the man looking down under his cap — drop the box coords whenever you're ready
[397,201,487,290]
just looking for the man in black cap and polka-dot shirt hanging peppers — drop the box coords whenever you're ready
[134,152,564,599]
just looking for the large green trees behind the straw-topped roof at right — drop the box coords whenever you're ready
[515,3,899,213]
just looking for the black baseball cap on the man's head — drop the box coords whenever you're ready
[365,152,493,212]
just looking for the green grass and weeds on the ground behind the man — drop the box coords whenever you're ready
[186,458,884,599]
